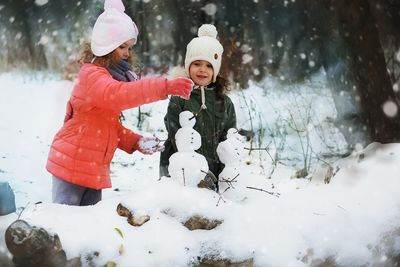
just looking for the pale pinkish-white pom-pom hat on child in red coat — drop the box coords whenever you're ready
[90,0,139,57]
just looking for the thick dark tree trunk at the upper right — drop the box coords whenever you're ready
[331,0,400,143]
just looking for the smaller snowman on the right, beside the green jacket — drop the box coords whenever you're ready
[217,128,244,192]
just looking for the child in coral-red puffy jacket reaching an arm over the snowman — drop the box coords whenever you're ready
[46,0,192,206]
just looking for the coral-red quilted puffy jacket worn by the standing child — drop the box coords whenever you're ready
[46,64,167,189]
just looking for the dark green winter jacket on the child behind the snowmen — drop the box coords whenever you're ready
[160,88,236,177]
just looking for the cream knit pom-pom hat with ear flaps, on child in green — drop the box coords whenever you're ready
[185,24,224,82]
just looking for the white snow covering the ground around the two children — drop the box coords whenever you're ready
[0,74,400,267]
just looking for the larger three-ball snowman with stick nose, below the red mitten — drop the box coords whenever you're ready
[168,111,208,187]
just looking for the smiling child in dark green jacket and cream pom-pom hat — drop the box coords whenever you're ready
[160,24,236,191]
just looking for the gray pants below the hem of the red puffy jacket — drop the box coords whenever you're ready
[52,176,101,206]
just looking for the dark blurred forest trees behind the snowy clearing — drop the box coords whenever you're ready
[0,0,400,155]
